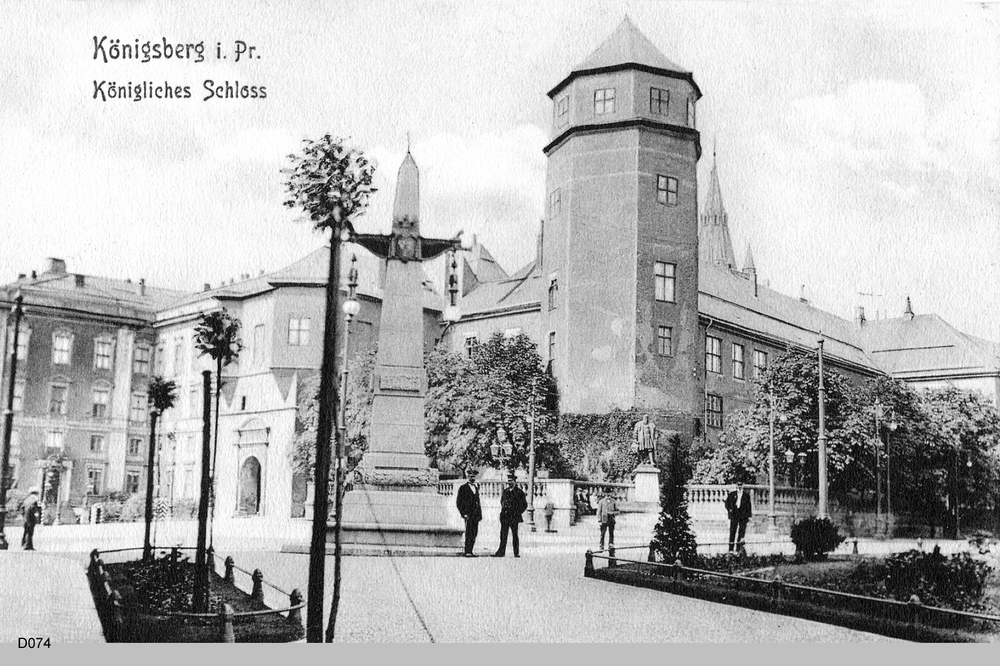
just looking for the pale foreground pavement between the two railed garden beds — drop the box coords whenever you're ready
[227,552,889,643]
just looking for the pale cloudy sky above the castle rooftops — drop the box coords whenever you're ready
[0,0,1000,339]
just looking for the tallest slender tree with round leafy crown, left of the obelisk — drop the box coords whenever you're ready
[283,134,376,643]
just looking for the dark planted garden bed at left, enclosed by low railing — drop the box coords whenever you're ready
[91,555,303,643]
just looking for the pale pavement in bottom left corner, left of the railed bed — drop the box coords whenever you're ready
[0,550,104,644]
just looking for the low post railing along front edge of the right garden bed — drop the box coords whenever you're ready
[583,544,1000,629]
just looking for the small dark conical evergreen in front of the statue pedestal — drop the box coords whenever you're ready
[650,434,698,566]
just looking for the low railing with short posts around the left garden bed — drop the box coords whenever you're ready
[87,546,306,643]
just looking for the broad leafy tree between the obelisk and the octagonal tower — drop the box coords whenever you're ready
[425,333,565,472]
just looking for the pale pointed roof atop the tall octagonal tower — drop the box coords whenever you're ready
[549,16,701,97]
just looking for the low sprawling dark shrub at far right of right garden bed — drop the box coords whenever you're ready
[885,546,992,610]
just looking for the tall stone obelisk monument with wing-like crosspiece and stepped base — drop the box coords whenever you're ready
[341,151,462,549]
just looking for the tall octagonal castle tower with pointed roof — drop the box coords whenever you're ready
[541,19,703,434]
